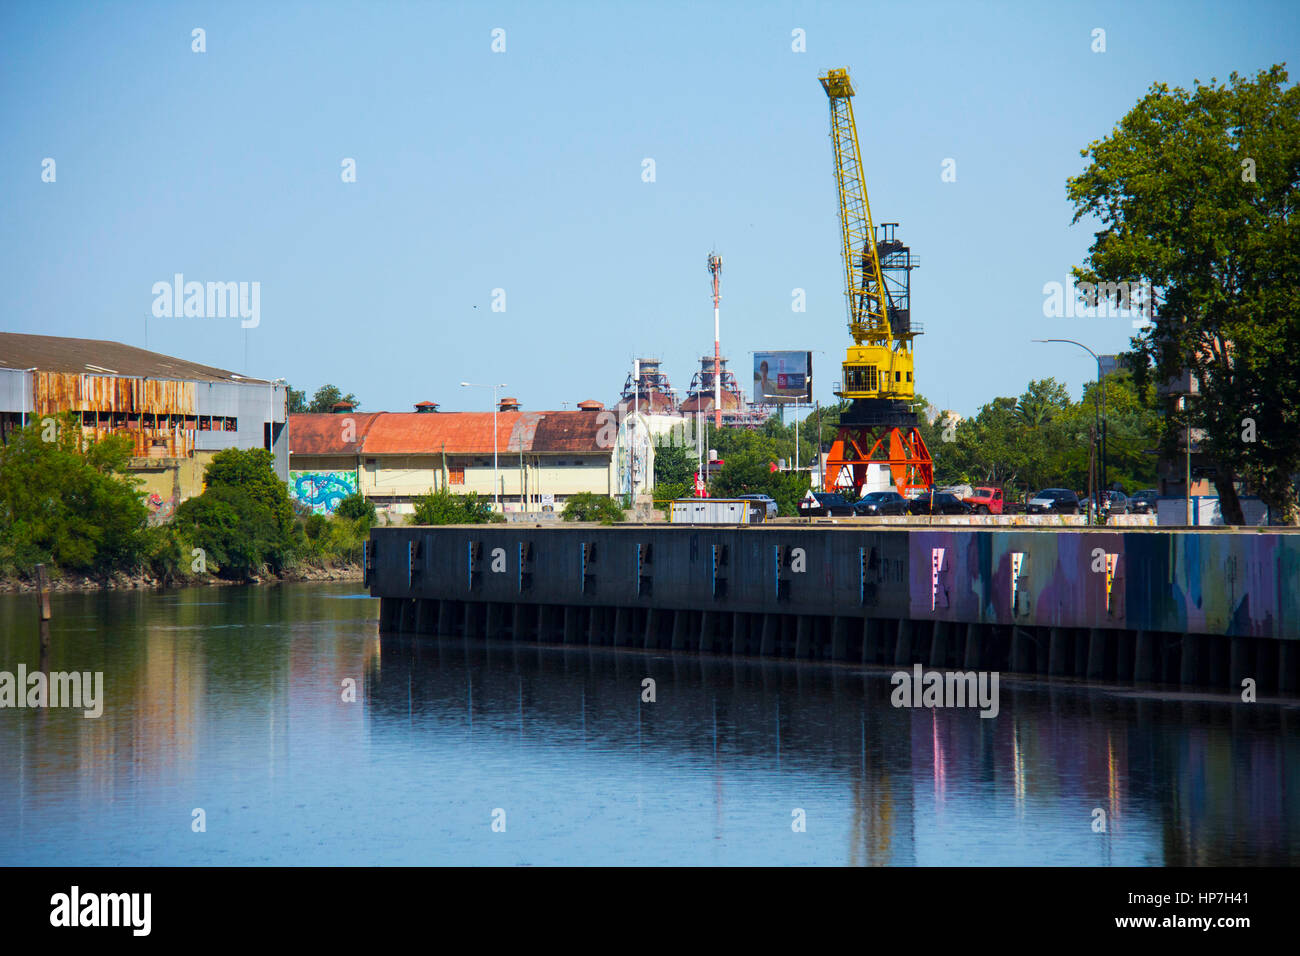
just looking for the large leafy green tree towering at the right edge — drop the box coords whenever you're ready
[1067,65,1300,524]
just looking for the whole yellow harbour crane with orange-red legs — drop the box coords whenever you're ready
[819,69,933,493]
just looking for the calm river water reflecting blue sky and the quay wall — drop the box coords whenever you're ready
[0,584,1300,866]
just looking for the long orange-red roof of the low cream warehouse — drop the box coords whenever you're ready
[289,411,608,455]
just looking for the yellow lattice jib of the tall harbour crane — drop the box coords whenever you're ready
[819,69,892,345]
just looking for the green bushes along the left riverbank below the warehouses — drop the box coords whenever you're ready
[0,415,374,584]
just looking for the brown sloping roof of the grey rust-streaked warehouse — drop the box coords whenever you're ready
[0,332,270,385]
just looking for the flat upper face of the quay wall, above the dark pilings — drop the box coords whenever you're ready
[371,525,1300,644]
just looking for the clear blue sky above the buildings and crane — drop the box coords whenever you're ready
[0,1,1300,414]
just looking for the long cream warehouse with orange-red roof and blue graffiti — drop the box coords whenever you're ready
[289,398,654,516]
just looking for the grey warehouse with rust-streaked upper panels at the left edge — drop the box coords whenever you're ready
[0,332,289,518]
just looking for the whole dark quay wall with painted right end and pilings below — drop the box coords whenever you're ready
[367,525,1300,692]
